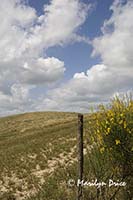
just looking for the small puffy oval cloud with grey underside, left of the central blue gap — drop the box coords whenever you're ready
[21,57,65,85]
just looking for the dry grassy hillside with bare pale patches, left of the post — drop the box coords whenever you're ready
[0,112,89,200]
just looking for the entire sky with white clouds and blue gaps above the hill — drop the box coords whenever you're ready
[0,0,133,116]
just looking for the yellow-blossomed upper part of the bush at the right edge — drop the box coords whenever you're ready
[88,97,133,178]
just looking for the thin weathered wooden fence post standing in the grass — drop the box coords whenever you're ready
[77,114,84,200]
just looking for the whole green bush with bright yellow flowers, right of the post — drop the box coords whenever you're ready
[86,96,133,199]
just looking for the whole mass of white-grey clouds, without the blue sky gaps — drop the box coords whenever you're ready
[0,0,133,113]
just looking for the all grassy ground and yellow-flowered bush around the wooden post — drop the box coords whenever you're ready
[0,100,133,200]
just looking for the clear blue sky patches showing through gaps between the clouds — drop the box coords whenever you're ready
[28,0,113,81]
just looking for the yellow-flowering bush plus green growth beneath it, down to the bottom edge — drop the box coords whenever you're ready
[83,96,133,200]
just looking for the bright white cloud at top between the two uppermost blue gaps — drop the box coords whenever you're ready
[32,0,90,47]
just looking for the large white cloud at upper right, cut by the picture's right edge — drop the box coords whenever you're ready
[93,1,133,70]
